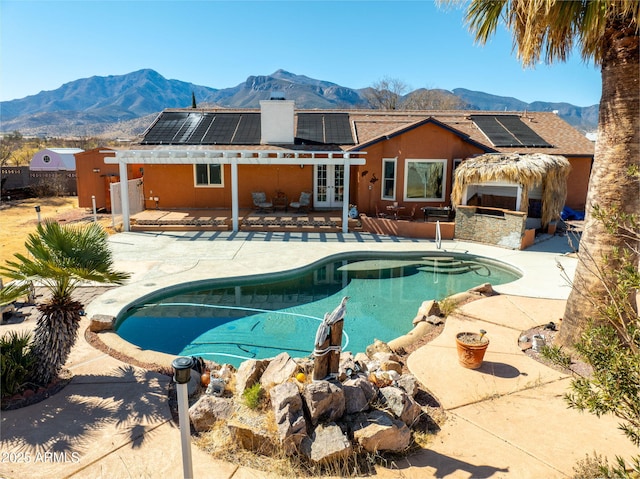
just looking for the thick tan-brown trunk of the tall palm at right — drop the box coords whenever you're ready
[558,21,640,347]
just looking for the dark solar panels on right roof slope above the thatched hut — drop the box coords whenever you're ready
[471,115,552,148]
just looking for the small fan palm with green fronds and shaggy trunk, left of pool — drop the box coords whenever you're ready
[0,220,129,385]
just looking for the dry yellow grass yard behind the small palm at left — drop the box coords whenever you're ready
[0,196,111,282]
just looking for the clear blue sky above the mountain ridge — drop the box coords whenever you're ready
[0,0,601,106]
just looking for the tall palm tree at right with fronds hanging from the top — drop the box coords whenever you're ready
[441,0,640,347]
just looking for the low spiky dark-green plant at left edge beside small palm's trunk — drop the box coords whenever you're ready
[0,331,35,397]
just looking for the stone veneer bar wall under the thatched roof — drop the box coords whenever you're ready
[455,205,527,249]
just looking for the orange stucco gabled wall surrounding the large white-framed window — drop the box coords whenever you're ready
[354,123,483,216]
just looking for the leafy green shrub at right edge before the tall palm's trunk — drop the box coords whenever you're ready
[565,208,640,462]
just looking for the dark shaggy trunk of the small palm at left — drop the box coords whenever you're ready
[32,297,82,386]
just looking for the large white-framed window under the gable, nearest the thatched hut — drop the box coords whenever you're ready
[404,160,447,201]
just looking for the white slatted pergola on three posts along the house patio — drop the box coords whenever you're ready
[104,149,366,233]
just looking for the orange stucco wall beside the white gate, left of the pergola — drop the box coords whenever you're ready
[74,148,142,211]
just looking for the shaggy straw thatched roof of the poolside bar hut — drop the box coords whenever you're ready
[451,153,571,226]
